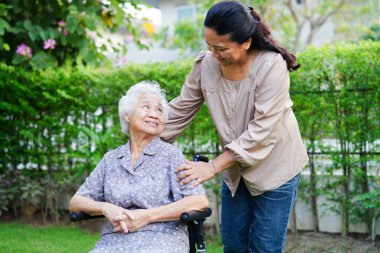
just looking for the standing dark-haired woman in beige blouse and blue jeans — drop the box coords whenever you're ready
[161,1,308,253]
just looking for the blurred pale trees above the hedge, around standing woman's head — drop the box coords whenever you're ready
[160,0,380,53]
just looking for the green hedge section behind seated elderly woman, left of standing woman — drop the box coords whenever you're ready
[0,54,218,217]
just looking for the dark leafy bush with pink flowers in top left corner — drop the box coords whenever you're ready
[0,0,153,69]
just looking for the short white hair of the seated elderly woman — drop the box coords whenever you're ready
[119,81,169,135]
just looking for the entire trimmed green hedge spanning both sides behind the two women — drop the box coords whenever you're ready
[0,42,380,233]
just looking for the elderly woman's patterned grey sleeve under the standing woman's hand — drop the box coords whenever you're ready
[169,150,205,201]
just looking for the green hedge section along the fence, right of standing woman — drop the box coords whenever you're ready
[291,41,380,235]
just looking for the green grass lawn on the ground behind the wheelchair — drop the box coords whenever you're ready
[0,223,223,253]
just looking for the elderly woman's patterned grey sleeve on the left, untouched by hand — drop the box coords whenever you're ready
[76,157,107,201]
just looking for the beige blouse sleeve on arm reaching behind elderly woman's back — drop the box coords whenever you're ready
[160,51,206,143]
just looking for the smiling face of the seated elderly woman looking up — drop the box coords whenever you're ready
[126,94,164,137]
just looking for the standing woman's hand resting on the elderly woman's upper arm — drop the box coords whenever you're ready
[176,161,217,186]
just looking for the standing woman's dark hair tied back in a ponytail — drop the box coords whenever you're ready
[204,1,300,71]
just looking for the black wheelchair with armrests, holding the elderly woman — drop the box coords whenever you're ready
[70,155,212,253]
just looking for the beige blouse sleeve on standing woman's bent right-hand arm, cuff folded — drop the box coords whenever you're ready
[225,54,291,167]
